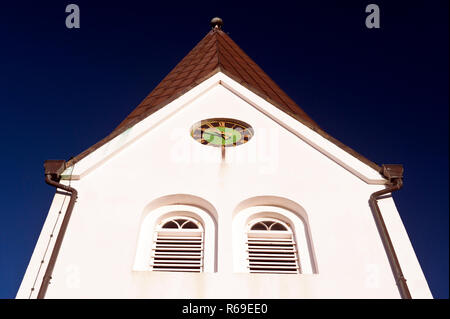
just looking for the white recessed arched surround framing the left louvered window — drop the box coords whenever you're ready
[133,205,216,272]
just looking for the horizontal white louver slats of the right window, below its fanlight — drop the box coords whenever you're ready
[246,232,301,274]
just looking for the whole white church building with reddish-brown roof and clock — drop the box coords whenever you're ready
[17,18,432,299]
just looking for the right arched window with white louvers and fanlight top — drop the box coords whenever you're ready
[246,218,301,274]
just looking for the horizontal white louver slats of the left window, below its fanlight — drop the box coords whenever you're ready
[151,232,203,272]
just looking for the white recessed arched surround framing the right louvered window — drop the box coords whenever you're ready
[232,205,315,274]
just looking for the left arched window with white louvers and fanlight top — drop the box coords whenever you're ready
[151,216,204,272]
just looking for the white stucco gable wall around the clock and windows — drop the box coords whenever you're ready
[17,74,431,298]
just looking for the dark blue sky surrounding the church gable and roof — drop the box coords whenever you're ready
[0,0,449,298]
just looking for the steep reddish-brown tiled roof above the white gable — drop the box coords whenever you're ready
[67,28,380,175]
